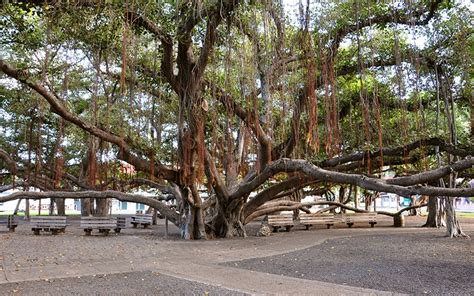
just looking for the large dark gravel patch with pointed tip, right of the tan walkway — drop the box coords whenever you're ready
[226,232,474,295]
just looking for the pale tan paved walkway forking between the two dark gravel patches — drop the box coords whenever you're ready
[0,219,474,295]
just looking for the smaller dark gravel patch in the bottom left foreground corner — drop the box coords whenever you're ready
[0,271,250,295]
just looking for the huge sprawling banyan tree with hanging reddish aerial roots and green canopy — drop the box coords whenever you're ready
[0,0,474,239]
